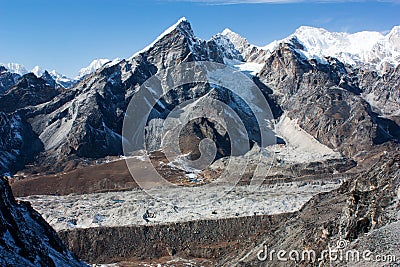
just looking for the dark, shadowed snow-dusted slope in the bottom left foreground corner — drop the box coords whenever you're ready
[0,178,87,267]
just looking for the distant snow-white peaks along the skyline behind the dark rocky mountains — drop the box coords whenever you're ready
[0,21,400,88]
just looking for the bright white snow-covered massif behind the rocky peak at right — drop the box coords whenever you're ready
[264,26,400,70]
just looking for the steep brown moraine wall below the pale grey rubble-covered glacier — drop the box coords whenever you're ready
[59,210,290,266]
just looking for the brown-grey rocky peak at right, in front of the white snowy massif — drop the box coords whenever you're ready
[259,44,400,157]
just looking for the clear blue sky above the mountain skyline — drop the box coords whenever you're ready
[0,0,400,77]
